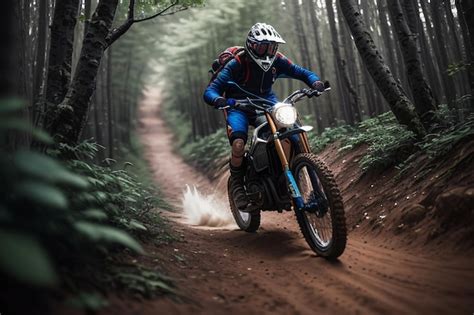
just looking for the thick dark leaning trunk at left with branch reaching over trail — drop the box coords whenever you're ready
[50,0,118,143]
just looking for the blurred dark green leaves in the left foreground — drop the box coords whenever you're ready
[0,102,174,309]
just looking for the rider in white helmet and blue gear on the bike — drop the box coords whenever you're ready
[204,23,324,210]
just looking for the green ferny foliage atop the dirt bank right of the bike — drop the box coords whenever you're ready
[310,105,474,171]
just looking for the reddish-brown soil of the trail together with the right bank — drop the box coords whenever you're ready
[103,90,474,314]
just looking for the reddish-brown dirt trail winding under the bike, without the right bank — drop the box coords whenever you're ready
[104,90,474,314]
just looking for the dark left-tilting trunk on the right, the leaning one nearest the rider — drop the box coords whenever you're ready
[339,0,425,137]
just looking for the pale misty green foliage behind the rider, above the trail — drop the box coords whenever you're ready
[154,0,276,139]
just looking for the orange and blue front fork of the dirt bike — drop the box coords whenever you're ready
[265,113,310,210]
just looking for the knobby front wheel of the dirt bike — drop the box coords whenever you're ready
[292,153,347,259]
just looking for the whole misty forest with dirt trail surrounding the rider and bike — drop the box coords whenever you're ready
[0,0,474,314]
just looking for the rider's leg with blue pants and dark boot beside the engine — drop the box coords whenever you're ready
[227,110,249,210]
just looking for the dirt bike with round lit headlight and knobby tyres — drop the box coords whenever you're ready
[220,82,347,259]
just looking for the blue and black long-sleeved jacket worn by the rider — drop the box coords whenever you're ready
[204,53,320,105]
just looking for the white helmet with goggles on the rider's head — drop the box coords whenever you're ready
[245,23,286,72]
